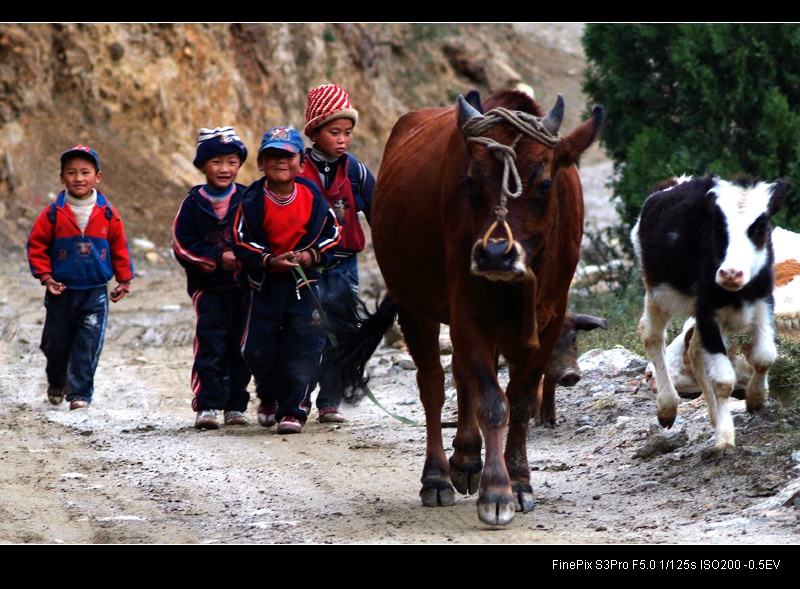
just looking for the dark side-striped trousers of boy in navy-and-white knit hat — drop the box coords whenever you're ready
[192,289,251,411]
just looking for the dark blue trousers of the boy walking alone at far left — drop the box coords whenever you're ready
[39,286,108,402]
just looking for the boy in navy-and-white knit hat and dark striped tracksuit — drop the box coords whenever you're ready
[172,127,251,429]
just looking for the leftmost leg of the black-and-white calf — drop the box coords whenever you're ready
[639,292,680,428]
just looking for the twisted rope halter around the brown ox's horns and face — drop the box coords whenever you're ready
[461,106,561,255]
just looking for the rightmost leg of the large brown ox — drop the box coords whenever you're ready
[504,370,541,513]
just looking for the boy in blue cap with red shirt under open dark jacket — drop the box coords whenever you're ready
[234,127,339,434]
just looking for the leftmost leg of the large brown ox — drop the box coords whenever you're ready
[397,311,455,507]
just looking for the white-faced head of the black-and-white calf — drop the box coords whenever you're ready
[708,179,788,292]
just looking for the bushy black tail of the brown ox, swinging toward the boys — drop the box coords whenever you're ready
[319,294,397,399]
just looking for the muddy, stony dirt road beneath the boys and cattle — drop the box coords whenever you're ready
[0,157,800,548]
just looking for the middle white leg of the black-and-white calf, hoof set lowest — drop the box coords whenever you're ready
[689,330,736,451]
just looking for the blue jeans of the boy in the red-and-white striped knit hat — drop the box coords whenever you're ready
[309,254,358,409]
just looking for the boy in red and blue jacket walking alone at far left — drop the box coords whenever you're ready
[26,145,133,409]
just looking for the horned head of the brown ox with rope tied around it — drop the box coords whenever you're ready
[456,91,602,282]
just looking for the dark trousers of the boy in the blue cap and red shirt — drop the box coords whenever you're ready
[242,273,323,423]
